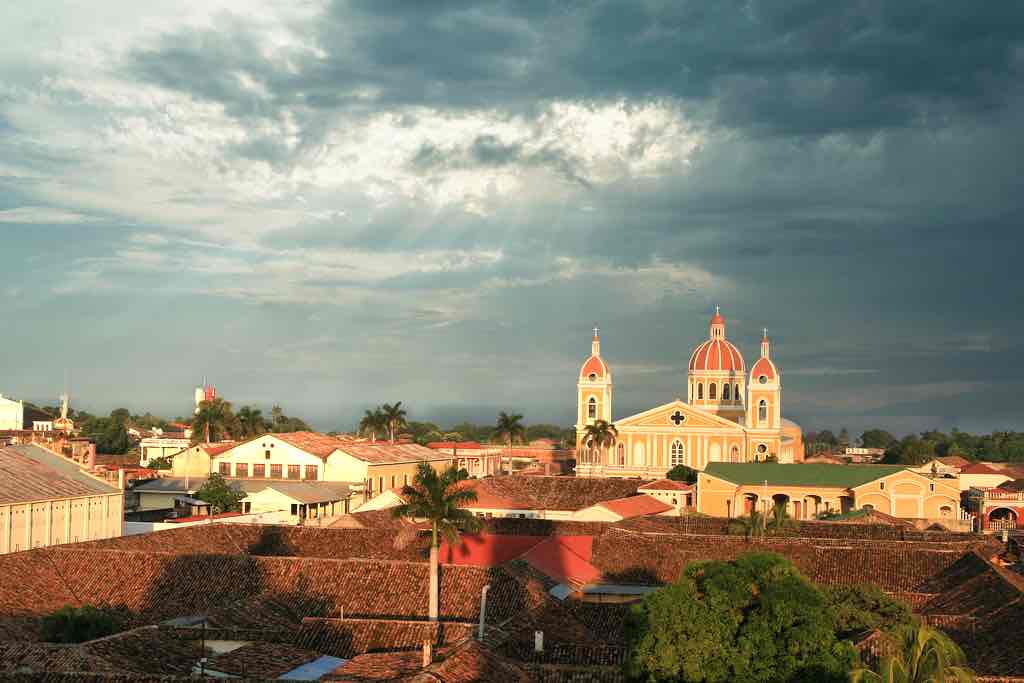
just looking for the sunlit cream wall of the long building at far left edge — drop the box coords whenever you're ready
[0,492,124,553]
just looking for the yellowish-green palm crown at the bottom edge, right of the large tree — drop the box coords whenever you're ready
[850,625,975,683]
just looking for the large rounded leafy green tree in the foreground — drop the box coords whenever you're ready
[626,553,856,683]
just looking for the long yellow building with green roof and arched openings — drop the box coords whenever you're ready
[696,463,959,520]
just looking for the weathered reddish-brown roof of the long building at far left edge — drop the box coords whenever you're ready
[0,445,118,505]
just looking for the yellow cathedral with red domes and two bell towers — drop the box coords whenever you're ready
[575,306,804,478]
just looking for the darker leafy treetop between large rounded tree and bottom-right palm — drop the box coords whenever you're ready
[823,584,916,639]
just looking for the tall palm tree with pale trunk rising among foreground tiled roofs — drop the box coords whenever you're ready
[391,463,480,622]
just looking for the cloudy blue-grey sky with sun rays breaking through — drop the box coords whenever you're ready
[0,0,1024,433]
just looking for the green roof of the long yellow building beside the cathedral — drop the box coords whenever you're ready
[703,463,906,488]
